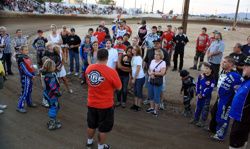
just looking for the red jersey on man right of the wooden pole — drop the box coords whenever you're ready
[196,34,210,52]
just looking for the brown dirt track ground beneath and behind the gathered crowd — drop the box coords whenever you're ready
[0,18,250,149]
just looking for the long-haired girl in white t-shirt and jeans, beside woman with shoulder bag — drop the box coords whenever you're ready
[130,46,145,112]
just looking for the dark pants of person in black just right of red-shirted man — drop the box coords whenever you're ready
[116,76,129,104]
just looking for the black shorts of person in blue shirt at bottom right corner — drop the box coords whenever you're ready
[230,120,250,148]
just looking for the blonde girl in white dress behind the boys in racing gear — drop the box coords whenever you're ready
[53,45,73,93]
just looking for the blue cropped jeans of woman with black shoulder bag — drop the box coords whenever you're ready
[148,82,163,104]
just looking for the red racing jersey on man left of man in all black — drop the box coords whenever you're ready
[161,31,175,50]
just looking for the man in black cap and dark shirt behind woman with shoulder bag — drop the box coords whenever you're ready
[143,38,170,109]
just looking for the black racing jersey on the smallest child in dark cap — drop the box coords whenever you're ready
[181,76,196,98]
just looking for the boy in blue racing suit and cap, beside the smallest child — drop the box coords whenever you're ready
[189,63,215,127]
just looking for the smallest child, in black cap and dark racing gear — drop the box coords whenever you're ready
[180,70,196,116]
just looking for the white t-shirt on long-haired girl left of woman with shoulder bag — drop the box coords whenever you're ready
[131,56,145,79]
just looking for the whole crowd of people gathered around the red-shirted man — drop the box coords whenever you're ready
[0,20,250,149]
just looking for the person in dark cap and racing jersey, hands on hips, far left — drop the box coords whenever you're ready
[32,30,48,74]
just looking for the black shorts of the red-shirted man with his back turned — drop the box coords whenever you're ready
[87,106,115,133]
